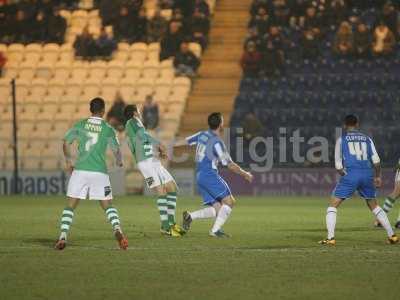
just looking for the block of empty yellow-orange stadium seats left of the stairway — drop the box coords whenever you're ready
[0,0,215,170]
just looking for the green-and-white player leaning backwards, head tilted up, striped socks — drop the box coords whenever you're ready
[125,105,185,237]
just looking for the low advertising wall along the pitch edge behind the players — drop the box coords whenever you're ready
[0,168,395,196]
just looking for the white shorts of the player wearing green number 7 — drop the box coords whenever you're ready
[67,170,112,200]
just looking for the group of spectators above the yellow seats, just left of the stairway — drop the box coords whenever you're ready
[98,0,211,77]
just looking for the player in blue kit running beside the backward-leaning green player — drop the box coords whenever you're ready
[183,113,253,237]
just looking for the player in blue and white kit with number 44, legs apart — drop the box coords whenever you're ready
[319,115,399,246]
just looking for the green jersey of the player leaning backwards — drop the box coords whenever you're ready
[125,118,160,162]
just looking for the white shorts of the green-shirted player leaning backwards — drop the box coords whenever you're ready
[138,158,175,188]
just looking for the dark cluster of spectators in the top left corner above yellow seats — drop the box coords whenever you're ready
[0,0,69,44]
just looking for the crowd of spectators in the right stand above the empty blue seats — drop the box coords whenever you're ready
[241,0,400,76]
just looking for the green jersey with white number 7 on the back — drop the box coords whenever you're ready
[64,117,119,174]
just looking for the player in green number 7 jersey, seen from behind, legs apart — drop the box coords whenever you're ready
[55,98,128,250]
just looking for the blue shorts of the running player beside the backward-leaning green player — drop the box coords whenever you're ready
[196,172,232,205]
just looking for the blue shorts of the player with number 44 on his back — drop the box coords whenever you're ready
[332,170,376,199]
